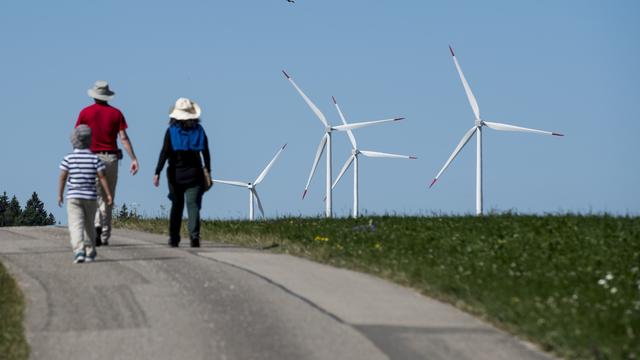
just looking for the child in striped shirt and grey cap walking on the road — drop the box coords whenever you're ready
[58,125,113,264]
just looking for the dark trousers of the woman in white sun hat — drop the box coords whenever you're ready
[169,184,204,247]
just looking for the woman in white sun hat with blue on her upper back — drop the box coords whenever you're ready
[153,98,211,247]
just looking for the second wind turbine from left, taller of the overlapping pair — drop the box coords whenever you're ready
[282,70,404,217]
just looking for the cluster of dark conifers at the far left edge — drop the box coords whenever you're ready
[0,191,56,226]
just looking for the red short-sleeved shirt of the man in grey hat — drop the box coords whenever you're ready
[76,104,127,152]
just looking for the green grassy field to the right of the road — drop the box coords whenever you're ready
[120,214,640,359]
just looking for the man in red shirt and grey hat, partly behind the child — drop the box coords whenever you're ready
[76,81,139,246]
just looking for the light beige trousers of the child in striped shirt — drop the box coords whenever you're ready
[67,199,96,256]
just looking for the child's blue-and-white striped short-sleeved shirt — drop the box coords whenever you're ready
[60,149,105,200]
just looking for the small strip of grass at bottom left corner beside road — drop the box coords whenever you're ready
[0,263,29,360]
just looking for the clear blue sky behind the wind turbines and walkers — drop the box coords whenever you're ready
[0,0,640,223]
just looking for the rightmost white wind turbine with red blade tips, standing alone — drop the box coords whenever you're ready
[429,46,564,215]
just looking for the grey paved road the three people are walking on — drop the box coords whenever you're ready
[0,227,549,360]
